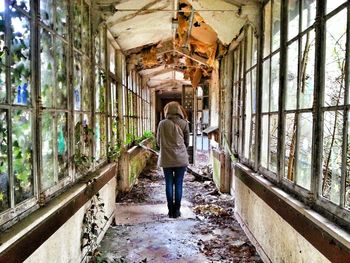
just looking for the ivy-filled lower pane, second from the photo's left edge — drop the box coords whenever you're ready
[12,110,34,204]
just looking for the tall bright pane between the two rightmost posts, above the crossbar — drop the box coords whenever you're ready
[324,10,347,106]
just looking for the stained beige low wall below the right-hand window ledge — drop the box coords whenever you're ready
[235,171,330,263]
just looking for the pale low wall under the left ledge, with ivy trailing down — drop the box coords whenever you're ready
[25,178,116,263]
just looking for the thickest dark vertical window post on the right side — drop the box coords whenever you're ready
[310,0,326,201]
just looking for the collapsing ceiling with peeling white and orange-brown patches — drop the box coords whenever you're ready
[96,0,259,91]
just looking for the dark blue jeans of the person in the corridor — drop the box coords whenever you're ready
[163,166,186,209]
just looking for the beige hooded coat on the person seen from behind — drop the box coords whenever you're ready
[157,102,189,168]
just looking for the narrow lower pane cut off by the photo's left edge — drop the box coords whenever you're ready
[0,111,10,212]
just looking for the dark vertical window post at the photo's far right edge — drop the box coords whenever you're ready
[340,2,350,208]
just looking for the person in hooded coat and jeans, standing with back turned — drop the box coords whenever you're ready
[157,101,189,218]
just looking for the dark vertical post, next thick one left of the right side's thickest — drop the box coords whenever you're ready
[271,1,288,182]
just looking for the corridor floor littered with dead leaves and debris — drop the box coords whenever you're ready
[98,158,262,263]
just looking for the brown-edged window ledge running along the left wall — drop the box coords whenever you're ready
[0,163,116,262]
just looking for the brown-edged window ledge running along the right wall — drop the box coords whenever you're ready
[235,163,350,262]
